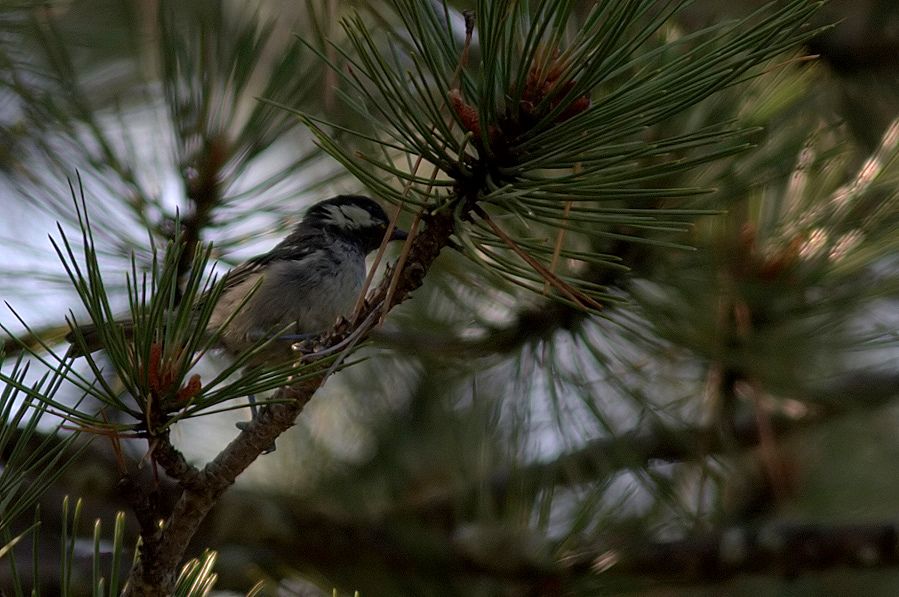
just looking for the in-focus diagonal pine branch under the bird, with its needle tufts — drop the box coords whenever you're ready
[1,0,836,595]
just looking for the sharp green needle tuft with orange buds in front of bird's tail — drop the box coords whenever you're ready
[0,179,342,436]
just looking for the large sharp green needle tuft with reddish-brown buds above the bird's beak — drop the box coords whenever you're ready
[292,0,828,311]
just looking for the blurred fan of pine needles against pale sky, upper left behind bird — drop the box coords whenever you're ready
[0,0,344,278]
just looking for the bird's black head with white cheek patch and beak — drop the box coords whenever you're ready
[302,195,408,253]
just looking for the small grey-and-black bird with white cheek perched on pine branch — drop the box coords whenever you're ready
[66,195,408,451]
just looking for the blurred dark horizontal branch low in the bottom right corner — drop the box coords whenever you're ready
[446,523,899,594]
